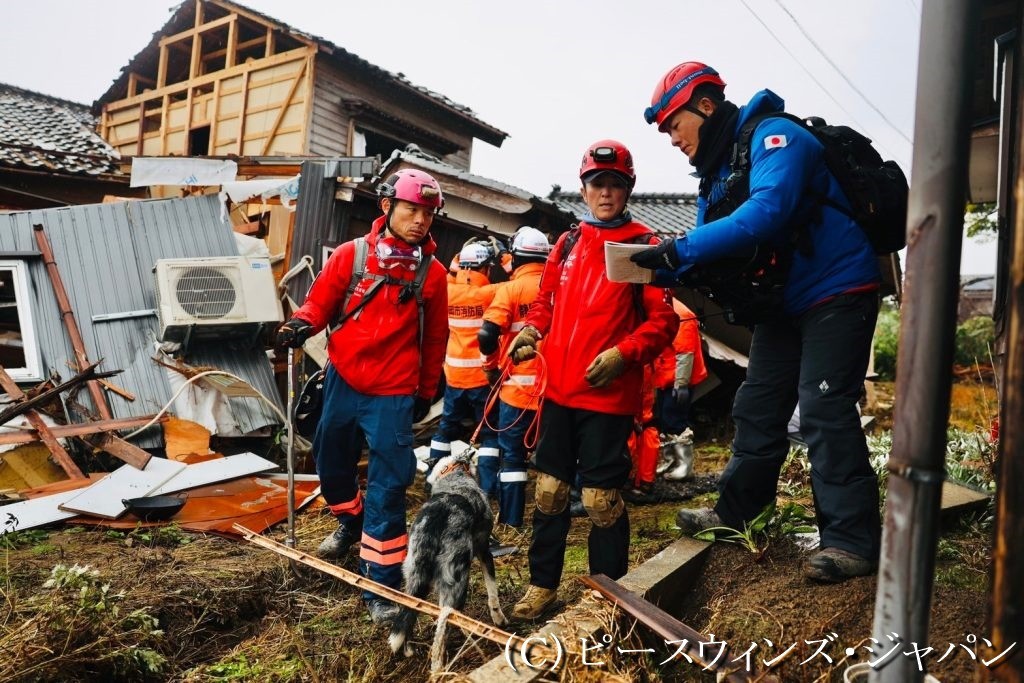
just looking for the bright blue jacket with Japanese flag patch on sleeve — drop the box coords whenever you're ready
[659,90,881,315]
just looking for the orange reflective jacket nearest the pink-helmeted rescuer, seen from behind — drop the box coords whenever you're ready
[444,270,499,389]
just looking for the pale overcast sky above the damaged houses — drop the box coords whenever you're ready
[0,0,994,272]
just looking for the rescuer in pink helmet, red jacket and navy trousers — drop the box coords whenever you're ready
[278,169,447,624]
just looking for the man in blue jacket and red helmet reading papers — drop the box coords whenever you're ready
[633,61,881,583]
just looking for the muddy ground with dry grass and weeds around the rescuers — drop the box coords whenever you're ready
[0,384,994,681]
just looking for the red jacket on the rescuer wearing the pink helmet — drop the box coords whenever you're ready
[294,216,447,398]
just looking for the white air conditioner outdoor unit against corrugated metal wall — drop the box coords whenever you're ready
[156,256,283,343]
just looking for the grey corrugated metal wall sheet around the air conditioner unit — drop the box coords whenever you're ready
[0,196,282,445]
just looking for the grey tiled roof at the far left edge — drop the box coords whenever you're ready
[0,84,119,176]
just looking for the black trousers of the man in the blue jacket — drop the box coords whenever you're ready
[715,292,882,559]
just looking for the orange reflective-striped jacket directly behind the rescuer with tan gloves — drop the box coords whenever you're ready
[483,263,544,411]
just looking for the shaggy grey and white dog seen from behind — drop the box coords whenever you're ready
[388,455,507,672]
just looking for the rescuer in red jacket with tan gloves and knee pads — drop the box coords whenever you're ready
[509,140,679,618]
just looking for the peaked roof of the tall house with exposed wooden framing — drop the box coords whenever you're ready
[93,0,508,146]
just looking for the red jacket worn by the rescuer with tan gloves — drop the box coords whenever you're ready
[526,221,679,415]
